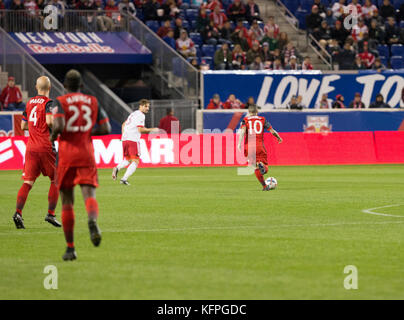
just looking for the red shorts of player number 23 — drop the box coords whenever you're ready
[56,166,98,189]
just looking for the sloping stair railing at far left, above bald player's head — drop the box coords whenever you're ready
[0,28,64,98]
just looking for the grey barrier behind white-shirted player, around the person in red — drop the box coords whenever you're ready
[129,99,199,130]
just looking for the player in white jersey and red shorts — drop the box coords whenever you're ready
[112,99,159,185]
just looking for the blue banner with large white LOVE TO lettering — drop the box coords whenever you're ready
[202,71,404,109]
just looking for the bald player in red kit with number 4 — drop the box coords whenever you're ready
[13,76,62,229]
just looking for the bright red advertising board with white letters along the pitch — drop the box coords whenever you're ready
[0,131,404,170]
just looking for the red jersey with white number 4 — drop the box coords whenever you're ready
[22,96,53,152]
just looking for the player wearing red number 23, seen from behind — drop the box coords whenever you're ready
[51,70,111,260]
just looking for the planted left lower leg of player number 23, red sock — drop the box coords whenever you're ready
[60,188,77,261]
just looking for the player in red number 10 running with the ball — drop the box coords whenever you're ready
[238,105,282,191]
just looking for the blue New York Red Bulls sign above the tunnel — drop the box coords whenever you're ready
[10,32,152,64]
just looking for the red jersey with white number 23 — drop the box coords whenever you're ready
[53,92,108,167]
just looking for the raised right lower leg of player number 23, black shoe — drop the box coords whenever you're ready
[80,185,101,247]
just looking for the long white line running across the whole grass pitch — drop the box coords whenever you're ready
[0,216,404,236]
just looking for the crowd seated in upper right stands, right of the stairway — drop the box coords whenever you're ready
[302,0,404,71]
